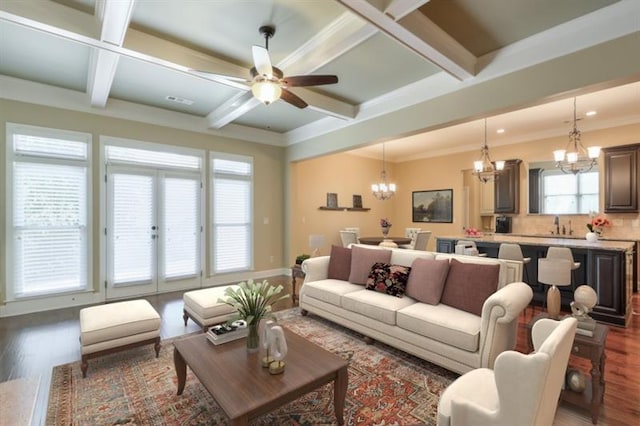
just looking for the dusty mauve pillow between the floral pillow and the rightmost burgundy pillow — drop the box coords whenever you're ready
[406,259,449,305]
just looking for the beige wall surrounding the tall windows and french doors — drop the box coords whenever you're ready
[0,100,288,310]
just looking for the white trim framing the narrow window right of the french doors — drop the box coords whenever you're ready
[209,151,255,276]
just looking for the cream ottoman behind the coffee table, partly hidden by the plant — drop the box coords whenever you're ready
[182,286,238,332]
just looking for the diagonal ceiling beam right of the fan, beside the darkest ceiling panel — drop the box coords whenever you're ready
[338,0,476,81]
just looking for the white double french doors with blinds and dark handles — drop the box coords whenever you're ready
[106,165,202,299]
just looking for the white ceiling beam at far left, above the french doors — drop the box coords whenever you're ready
[87,0,135,108]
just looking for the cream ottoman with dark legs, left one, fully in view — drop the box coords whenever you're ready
[80,300,160,377]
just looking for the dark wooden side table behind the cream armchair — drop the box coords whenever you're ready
[527,313,609,424]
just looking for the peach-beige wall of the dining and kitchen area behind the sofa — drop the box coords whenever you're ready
[291,124,640,256]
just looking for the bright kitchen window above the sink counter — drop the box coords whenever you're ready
[542,170,598,214]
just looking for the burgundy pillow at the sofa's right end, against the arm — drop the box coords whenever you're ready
[440,259,500,315]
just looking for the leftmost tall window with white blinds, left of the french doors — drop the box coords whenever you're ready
[7,124,91,300]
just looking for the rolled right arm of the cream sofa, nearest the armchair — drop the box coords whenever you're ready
[479,281,533,369]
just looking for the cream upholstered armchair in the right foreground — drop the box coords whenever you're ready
[438,317,577,426]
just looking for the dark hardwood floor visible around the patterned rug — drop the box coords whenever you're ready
[0,277,640,426]
